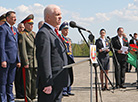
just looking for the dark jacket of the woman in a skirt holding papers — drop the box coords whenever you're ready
[95,38,110,58]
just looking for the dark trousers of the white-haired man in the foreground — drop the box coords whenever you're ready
[38,86,62,102]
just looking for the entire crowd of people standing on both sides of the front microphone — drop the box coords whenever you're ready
[0,5,138,102]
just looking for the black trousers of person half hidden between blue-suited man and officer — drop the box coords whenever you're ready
[15,68,24,98]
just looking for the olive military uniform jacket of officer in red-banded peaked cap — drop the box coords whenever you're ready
[18,30,37,68]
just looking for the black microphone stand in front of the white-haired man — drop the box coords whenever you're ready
[78,28,114,102]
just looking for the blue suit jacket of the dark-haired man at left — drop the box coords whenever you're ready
[0,23,20,63]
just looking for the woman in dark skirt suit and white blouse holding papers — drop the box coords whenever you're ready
[95,29,110,91]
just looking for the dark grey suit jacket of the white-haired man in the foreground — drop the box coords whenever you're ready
[35,24,72,89]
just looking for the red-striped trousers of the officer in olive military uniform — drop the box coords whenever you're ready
[23,68,37,102]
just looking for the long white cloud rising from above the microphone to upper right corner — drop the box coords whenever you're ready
[66,0,138,23]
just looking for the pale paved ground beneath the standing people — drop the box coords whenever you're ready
[15,58,138,102]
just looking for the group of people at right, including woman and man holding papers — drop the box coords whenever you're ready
[95,27,138,91]
